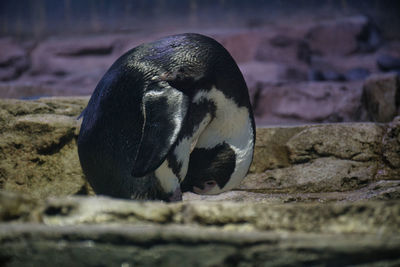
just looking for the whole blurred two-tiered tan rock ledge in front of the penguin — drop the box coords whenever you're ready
[0,193,400,266]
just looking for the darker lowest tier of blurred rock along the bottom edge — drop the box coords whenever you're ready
[0,225,400,266]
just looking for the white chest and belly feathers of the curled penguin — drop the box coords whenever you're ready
[155,88,254,194]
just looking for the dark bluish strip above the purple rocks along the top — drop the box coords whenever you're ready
[0,0,400,37]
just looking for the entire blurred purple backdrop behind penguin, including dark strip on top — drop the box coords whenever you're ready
[0,0,400,126]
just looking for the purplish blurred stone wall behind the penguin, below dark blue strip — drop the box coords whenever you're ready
[0,15,400,126]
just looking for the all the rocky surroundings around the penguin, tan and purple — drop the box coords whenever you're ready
[0,0,400,267]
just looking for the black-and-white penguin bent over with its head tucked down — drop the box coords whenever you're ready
[77,33,255,202]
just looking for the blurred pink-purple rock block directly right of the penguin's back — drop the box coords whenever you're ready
[253,82,365,126]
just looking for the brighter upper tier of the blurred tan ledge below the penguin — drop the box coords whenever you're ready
[0,193,400,234]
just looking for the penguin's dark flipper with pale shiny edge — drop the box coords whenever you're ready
[132,82,189,177]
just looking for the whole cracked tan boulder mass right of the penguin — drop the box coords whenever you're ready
[244,122,400,193]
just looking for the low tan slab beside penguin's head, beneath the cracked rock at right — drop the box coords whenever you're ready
[239,157,378,193]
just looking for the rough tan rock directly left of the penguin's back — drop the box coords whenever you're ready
[0,98,88,198]
